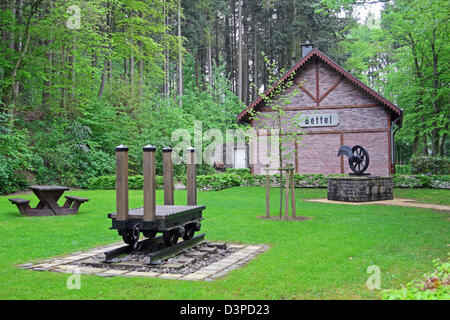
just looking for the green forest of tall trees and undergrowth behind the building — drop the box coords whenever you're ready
[0,0,450,193]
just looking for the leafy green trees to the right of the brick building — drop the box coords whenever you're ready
[328,0,450,162]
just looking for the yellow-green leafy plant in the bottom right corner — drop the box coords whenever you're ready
[383,259,450,300]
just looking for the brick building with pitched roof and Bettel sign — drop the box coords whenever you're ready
[238,45,403,176]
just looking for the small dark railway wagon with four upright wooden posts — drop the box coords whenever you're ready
[108,145,206,246]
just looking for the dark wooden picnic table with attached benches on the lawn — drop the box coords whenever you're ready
[9,186,89,216]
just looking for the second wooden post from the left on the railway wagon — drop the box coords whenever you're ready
[143,145,156,222]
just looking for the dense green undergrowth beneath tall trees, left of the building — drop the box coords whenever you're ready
[0,51,241,193]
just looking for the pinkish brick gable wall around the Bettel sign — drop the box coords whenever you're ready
[252,61,390,175]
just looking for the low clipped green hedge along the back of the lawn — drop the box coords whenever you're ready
[88,170,450,191]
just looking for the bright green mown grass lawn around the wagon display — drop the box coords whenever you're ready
[0,188,450,299]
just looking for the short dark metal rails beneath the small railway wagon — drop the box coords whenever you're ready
[103,233,205,265]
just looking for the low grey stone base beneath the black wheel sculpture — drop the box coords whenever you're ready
[328,176,394,202]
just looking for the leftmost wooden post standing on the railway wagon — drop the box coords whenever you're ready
[116,145,128,221]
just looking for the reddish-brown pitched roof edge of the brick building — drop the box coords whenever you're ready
[237,49,403,125]
